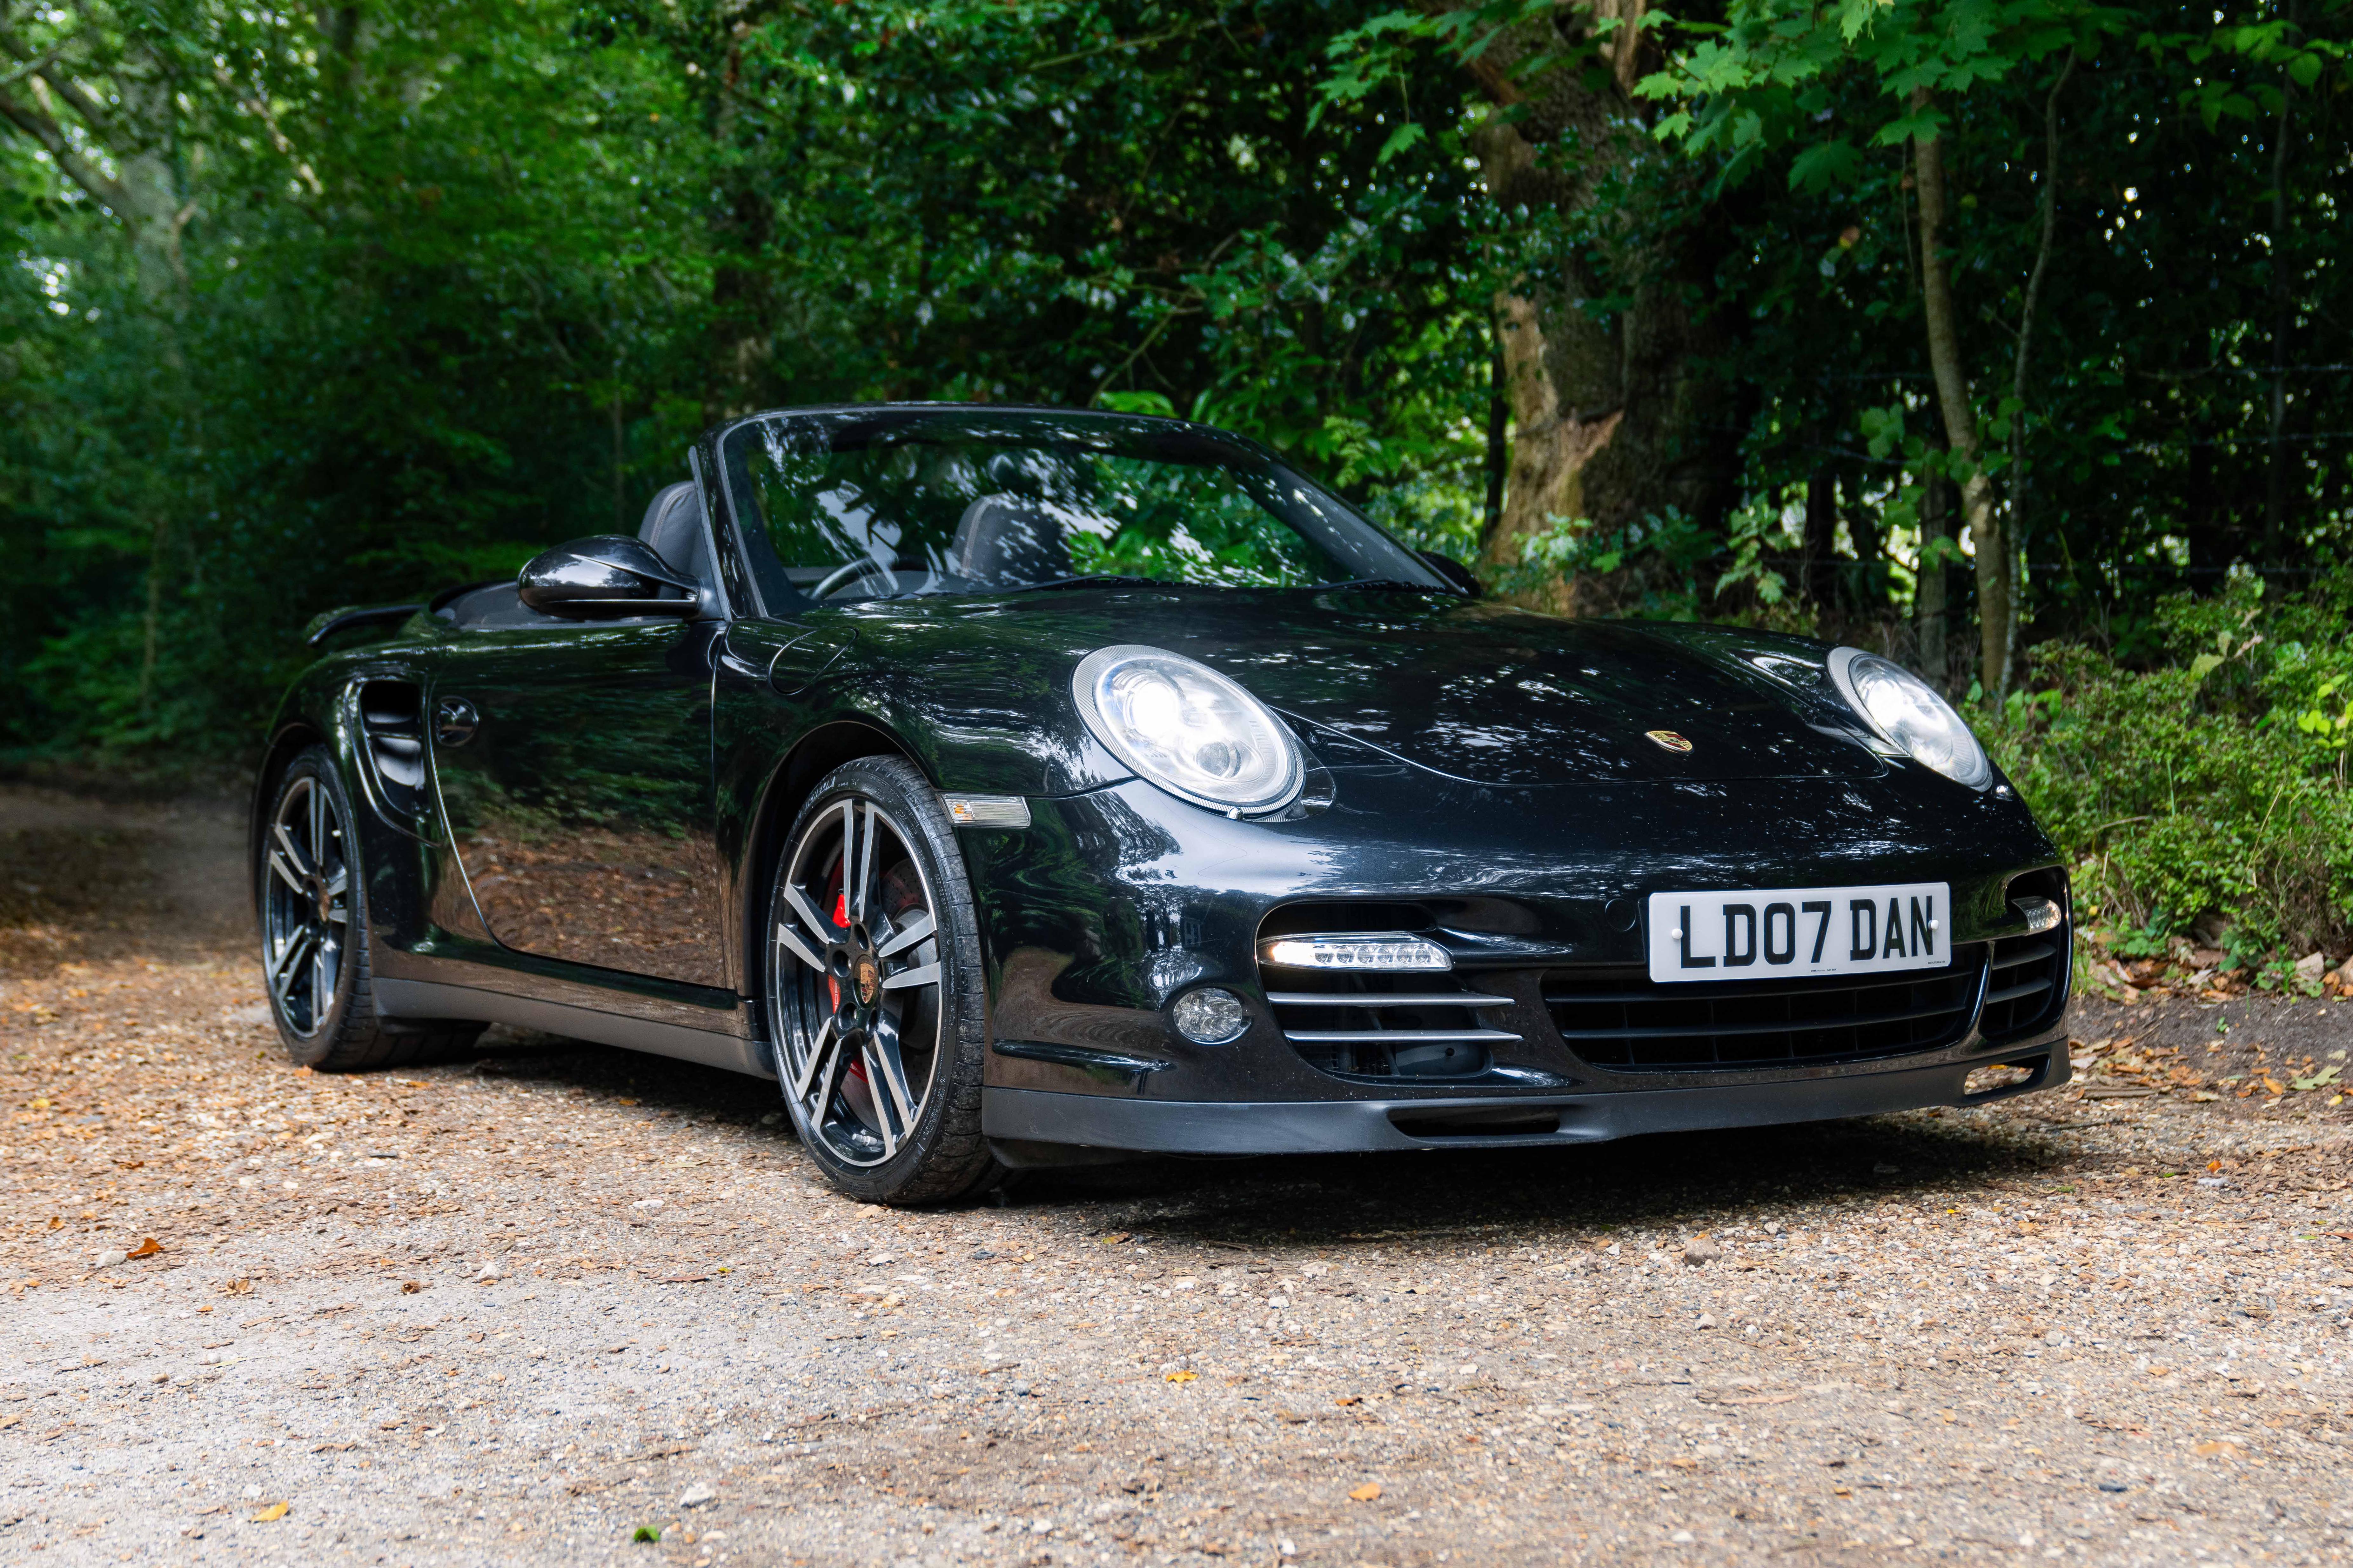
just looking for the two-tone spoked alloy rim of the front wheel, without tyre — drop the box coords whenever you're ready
[772,795,943,1166]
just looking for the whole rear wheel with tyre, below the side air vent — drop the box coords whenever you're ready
[254,745,482,1072]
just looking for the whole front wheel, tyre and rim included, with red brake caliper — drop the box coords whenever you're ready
[762,757,1005,1206]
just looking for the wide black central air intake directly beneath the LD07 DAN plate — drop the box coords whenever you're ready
[1544,945,1986,1072]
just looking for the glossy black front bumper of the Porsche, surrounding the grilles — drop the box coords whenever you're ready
[960,769,2068,1154]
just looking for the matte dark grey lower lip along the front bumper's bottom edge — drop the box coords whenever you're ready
[981,1044,2068,1166]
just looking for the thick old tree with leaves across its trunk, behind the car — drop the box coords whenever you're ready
[1327,0,1734,611]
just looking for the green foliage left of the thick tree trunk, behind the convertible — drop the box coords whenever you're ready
[0,0,1490,755]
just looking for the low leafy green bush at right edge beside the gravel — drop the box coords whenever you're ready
[1979,569,2353,966]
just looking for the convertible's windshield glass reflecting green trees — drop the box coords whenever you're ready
[722,409,1445,611]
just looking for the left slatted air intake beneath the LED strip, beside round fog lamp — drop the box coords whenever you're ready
[1266,964,1520,1079]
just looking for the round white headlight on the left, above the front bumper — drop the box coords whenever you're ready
[1071,646,1306,816]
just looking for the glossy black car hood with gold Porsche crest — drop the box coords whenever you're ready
[845,588,1885,785]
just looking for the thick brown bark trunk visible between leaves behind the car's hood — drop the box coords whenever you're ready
[1468,0,1732,614]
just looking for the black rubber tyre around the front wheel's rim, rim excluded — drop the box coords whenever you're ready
[760,757,988,1204]
